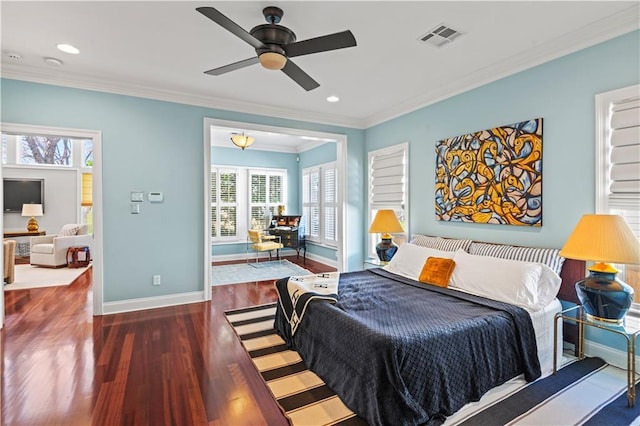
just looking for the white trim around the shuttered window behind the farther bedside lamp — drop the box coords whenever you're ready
[365,142,410,258]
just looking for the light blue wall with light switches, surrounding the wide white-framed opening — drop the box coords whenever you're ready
[0,79,364,302]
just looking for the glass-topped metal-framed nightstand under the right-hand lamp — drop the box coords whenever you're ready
[553,305,640,407]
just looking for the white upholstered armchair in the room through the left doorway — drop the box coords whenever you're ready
[30,224,93,268]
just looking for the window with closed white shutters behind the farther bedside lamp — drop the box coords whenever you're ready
[367,143,409,257]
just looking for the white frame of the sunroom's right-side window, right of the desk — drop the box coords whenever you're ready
[300,161,340,248]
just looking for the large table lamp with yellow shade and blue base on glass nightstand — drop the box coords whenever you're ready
[560,214,640,323]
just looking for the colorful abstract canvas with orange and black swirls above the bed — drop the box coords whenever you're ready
[435,118,542,226]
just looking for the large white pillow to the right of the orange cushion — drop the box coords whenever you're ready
[449,250,561,311]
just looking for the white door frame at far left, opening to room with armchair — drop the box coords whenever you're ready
[0,123,104,328]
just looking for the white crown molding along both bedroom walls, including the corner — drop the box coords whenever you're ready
[1,2,640,129]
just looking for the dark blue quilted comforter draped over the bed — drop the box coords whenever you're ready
[275,269,540,425]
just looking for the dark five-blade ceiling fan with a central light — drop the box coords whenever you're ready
[196,6,356,91]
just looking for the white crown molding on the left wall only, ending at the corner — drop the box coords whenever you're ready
[0,64,364,129]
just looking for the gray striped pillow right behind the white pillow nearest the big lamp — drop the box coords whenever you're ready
[469,242,564,275]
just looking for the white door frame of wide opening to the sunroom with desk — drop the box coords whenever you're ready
[202,117,348,300]
